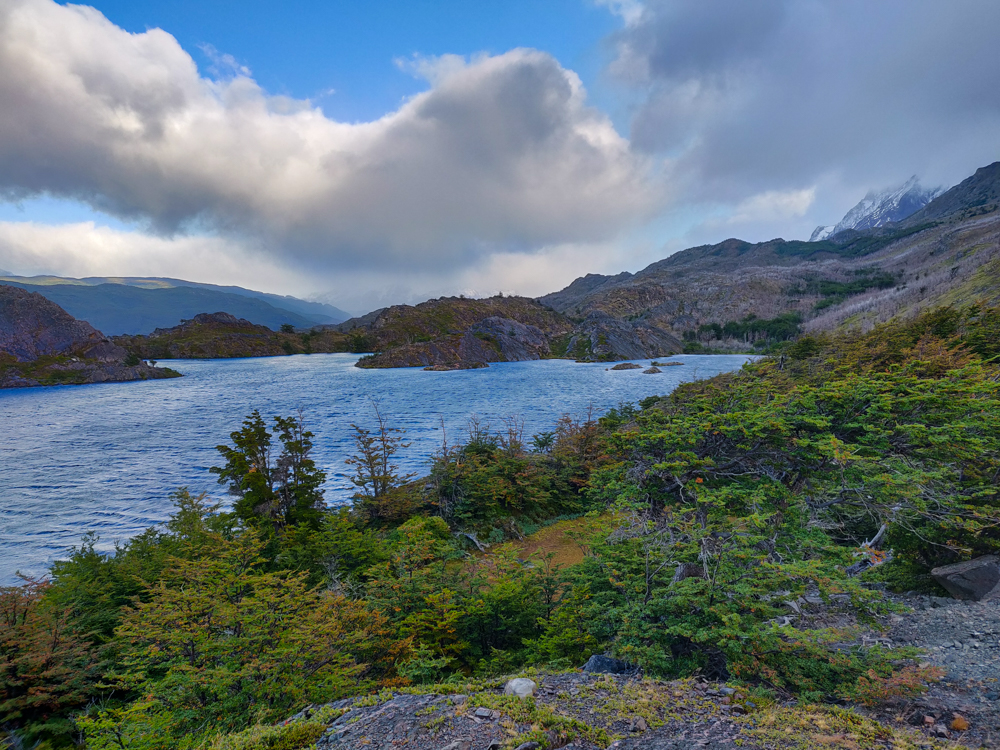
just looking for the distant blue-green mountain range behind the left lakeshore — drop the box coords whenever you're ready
[0,274,350,336]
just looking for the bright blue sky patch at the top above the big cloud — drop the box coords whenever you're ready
[72,0,621,121]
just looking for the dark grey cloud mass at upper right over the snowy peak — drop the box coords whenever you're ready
[612,0,1000,209]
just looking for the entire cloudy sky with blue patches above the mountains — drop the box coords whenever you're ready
[0,0,1000,313]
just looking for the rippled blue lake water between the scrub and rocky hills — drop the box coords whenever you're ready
[0,354,748,584]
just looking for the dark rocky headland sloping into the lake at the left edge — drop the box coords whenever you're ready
[0,285,177,388]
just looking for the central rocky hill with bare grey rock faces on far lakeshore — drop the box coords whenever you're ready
[336,296,681,369]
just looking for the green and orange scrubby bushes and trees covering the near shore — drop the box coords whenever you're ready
[0,306,1000,750]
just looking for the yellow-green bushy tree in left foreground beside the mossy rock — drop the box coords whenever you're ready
[82,530,392,748]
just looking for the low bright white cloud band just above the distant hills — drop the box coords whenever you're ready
[0,221,640,315]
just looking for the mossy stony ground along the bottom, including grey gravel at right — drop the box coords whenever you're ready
[272,594,1000,750]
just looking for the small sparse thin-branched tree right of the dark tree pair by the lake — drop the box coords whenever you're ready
[347,400,416,521]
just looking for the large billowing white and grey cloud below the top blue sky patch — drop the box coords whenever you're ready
[0,0,659,273]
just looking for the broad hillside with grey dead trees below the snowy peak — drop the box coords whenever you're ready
[539,162,1000,346]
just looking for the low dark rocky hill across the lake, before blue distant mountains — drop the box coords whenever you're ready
[115,312,350,359]
